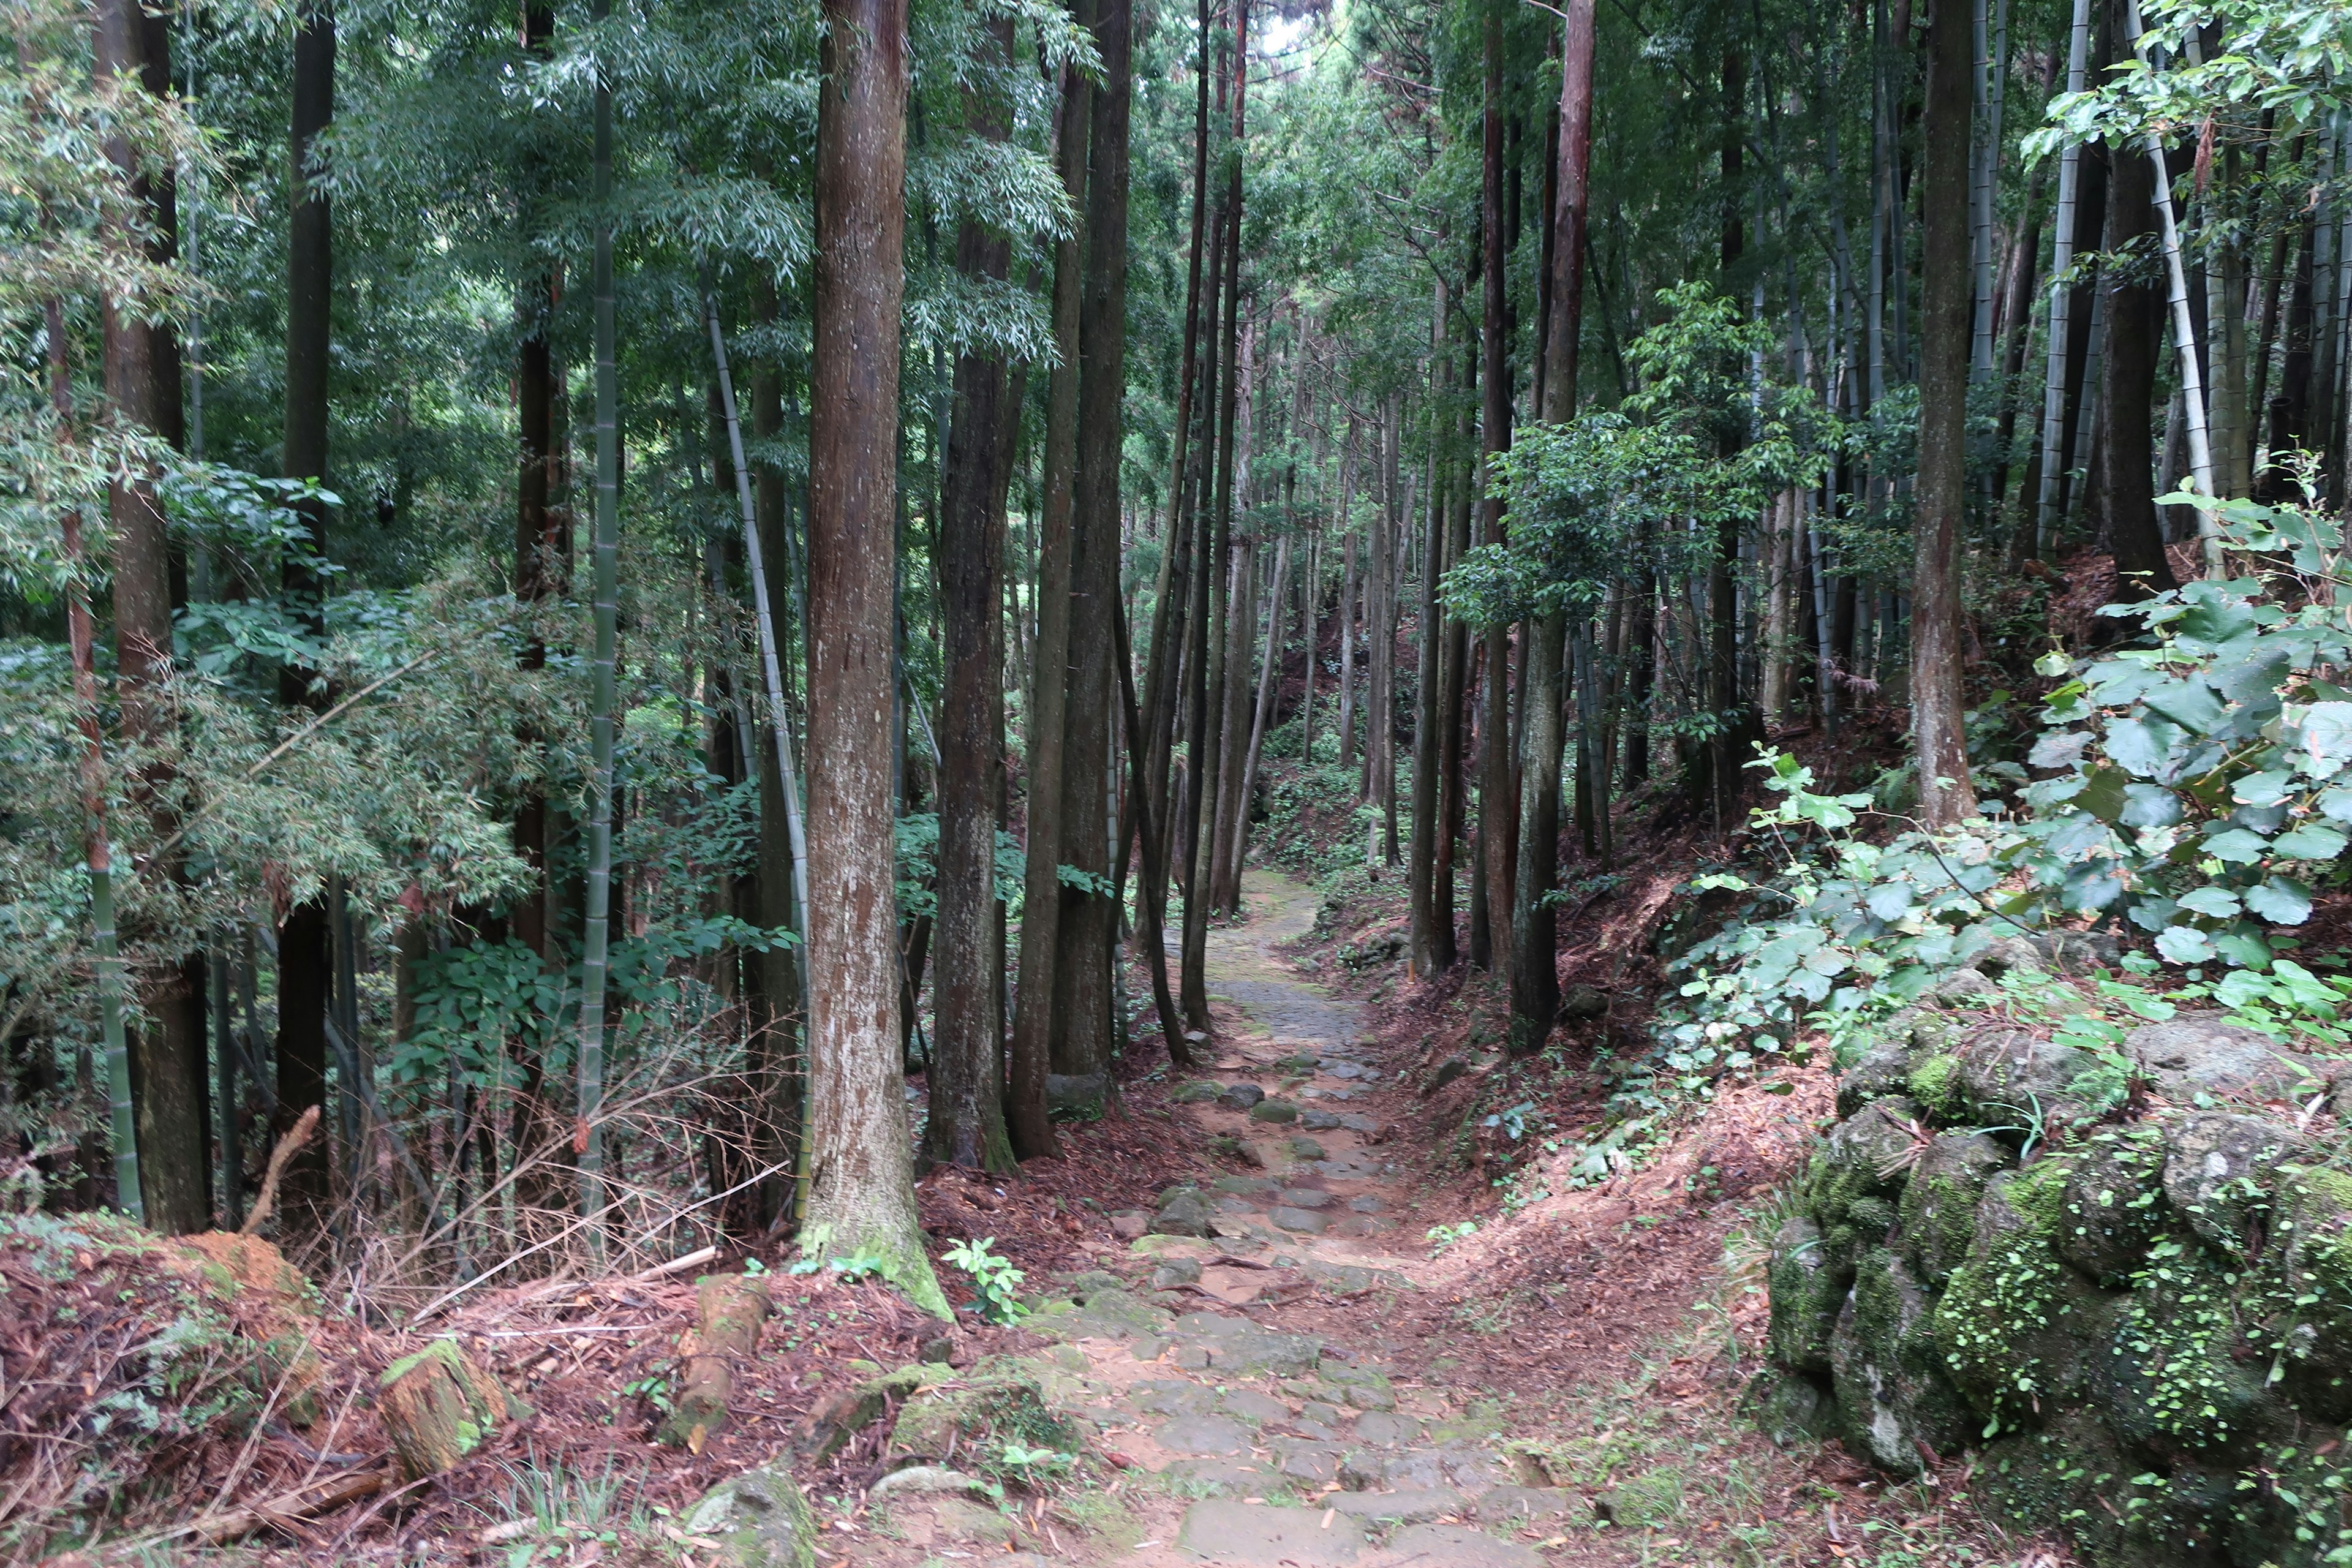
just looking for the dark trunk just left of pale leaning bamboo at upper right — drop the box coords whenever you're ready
[2100,88,2173,600]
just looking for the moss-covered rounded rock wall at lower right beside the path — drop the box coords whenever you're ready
[1759,954,2352,1568]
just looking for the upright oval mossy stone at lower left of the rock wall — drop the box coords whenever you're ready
[1830,1246,1973,1476]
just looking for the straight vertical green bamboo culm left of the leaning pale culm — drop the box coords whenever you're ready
[574,0,621,1257]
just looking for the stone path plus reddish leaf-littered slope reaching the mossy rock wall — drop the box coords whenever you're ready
[826,870,2065,1568]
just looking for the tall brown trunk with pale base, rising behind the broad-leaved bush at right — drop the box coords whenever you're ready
[1910,0,1976,827]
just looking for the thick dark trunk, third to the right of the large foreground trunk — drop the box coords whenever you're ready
[1051,0,1134,1102]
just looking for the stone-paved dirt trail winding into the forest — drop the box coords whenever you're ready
[851,870,1571,1568]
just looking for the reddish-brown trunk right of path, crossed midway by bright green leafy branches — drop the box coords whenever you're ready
[1510,0,1589,1051]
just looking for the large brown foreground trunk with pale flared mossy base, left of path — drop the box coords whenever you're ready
[802,0,948,1316]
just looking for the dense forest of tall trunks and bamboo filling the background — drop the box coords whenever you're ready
[0,0,2352,1305]
